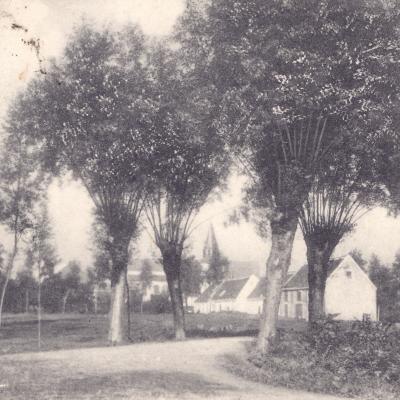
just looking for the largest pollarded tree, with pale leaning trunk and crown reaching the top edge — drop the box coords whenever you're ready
[181,0,398,351]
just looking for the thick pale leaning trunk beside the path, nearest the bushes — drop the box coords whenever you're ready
[257,218,297,353]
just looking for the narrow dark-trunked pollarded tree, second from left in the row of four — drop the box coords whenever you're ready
[146,46,227,340]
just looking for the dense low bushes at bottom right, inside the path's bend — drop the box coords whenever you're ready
[233,319,400,399]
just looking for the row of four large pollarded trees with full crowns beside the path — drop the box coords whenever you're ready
[4,0,400,351]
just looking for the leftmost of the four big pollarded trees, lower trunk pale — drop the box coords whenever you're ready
[9,25,151,344]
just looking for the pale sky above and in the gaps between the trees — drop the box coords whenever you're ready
[0,0,400,269]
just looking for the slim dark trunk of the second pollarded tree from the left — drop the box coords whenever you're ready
[163,247,186,340]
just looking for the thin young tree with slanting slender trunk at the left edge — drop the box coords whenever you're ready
[0,118,47,326]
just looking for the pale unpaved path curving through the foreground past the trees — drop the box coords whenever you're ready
[0,338,344,400]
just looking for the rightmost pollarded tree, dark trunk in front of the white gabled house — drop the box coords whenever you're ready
[300,135,385,324]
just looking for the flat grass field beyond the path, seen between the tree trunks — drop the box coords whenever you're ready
[0,313,304,354]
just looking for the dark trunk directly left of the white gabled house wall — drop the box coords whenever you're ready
[306,238,333,325]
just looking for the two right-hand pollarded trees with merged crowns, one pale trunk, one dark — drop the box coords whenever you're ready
[179,0,400,351]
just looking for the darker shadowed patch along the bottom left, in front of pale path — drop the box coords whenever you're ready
[0,360,231,400]
